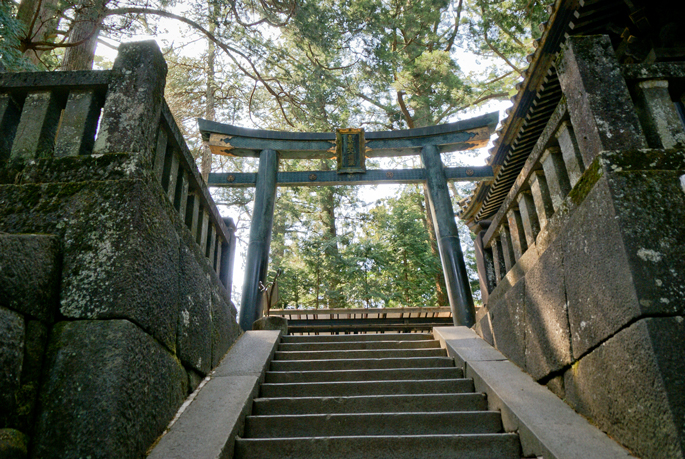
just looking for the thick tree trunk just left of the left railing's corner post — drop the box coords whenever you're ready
[61,0,109,70]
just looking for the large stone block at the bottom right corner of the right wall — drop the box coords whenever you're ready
[564,316,685,459]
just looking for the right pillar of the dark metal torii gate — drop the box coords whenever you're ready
[421,145,476,327]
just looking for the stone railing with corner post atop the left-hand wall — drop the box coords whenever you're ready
[0,42,235,292]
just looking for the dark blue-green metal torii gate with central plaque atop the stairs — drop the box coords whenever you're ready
[198,112,499,330]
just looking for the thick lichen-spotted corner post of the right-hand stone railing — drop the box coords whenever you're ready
[556,35,647,165]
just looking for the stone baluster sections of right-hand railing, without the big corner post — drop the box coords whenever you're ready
[477,55,685,295]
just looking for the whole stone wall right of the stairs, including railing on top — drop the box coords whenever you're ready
[476,37,685,458]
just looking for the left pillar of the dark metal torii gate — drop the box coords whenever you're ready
[240,150,278,330]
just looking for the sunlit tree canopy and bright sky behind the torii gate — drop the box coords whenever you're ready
[0,0,546,307]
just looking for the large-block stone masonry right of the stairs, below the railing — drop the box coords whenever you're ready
[478,149,685,458]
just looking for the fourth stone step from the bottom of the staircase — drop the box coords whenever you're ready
[260,379,474,398]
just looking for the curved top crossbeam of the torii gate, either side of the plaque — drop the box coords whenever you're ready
[198,112,499,159]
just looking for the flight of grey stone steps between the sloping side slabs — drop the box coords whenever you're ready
[235,333,521,459]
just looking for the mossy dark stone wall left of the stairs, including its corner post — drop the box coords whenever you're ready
[0,43,240,458]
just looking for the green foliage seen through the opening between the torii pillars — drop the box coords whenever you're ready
[272,186,441,308]
